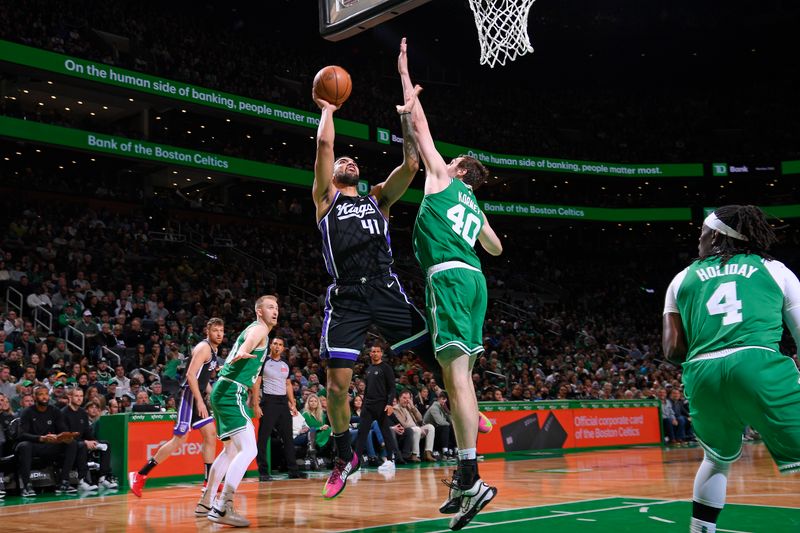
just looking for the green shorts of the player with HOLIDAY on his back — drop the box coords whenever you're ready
[683,348,800,473]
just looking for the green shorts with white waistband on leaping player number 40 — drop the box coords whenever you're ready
[425,261,488,361]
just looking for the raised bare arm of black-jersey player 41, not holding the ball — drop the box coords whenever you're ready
[370,86,422,210]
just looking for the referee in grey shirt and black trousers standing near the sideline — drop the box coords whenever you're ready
[256,337,306,481]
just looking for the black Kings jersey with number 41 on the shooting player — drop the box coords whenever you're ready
[319,192,394,281]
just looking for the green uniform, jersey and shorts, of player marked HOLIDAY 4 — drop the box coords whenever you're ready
[664,254,800,472]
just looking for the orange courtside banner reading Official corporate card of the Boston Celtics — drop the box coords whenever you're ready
[478,401,661,454]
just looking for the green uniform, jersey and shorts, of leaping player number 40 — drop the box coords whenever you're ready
[413,179,488,359]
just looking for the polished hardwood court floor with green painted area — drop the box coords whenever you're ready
[0,444,800,533]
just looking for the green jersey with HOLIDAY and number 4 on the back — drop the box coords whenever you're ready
[665,254,783,361]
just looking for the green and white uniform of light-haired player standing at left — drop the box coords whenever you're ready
[211,321,268,440]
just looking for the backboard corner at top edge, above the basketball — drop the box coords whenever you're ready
[319,0,430,41]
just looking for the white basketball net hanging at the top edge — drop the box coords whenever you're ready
[469,0,534,68]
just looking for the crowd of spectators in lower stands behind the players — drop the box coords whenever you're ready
[0,166,797,486]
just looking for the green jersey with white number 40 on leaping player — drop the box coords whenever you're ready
[413,179,483,271]
